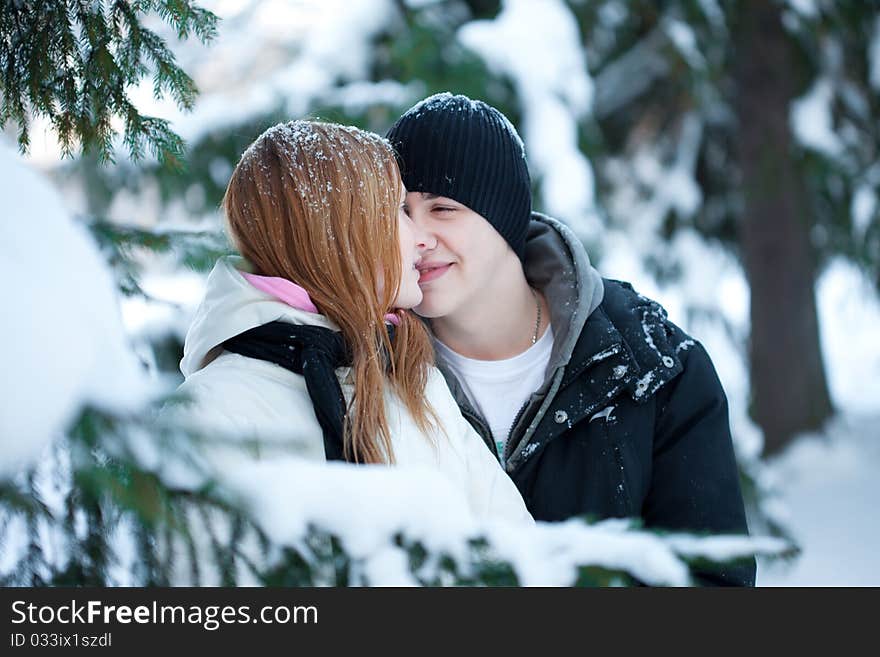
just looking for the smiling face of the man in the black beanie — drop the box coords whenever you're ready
[406,192,510,318]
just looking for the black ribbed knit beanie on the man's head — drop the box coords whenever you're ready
[386,92,532,260]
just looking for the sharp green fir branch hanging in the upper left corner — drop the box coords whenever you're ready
[0,0,218,168]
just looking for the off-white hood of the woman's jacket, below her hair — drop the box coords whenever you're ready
[180,256,339,377]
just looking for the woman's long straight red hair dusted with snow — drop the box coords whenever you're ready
[223,121,439,463]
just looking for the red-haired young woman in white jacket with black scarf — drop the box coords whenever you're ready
[172,121,531,522]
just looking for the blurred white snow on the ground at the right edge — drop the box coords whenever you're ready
[758,261,880,586]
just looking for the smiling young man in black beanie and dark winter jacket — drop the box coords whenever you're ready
[388,93,755,585]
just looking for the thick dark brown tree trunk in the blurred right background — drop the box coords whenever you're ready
[734,0,832,455]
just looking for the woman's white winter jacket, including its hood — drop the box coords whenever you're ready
[171,256,531,522]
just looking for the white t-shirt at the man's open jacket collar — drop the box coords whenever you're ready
[434,326,553,459]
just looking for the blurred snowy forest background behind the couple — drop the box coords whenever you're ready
[6,0,880,585]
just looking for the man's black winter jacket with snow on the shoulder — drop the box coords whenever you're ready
[441,215,755,586]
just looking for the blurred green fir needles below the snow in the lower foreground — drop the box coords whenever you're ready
[0,408,796,586]
